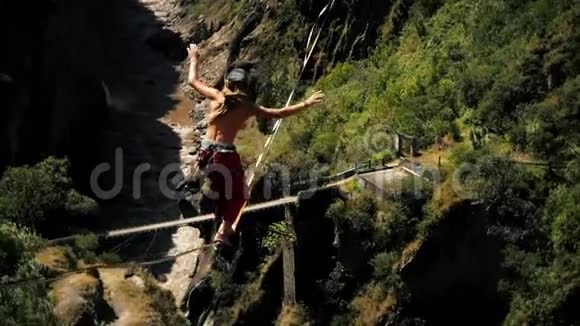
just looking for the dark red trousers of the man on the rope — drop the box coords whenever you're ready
[206,152,247,223]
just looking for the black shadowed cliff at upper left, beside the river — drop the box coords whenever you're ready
[0,0,112,178]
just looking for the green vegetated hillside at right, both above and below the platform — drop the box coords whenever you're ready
[266,0,580,325]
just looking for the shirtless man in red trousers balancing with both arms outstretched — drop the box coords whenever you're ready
[187,44,324,243]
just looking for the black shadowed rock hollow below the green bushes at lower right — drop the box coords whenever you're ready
[401,202,503,325]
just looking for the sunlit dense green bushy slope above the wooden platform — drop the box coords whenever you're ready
[279,1,579,171]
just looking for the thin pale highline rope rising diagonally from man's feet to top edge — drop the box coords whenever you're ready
[232,0,335,231]
